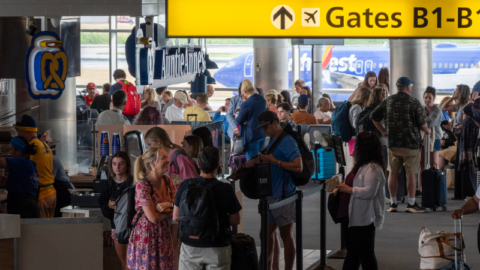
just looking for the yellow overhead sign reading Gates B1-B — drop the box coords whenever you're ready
[167,0,480,38]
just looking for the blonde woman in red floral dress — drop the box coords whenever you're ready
[127,147,177,270]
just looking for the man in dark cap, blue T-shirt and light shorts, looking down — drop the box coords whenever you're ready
[242,111,303,270]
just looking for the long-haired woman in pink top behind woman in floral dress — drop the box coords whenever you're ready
[145,127,198,269]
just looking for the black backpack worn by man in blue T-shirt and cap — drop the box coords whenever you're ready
[266,124,315,187]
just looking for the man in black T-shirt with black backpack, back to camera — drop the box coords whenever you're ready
[173,146,242,270]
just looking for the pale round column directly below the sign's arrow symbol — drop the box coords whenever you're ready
[253,39,290,93]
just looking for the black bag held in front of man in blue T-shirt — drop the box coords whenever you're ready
[240,162,273,200]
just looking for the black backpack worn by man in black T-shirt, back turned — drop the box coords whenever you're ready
[178,178,220,247]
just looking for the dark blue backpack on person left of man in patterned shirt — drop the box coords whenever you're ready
[332,101,355,142]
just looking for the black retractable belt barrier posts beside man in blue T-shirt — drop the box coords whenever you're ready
[258,180,327,270]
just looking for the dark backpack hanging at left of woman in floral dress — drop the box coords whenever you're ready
[113,178,153,245]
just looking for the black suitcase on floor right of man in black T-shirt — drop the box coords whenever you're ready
[230,233,260,270]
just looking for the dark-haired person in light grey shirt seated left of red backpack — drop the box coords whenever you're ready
[97,91,130,125]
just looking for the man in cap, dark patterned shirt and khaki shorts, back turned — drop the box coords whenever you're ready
[370,77,430,213]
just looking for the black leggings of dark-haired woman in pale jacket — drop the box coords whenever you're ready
[343,223,378,270]
